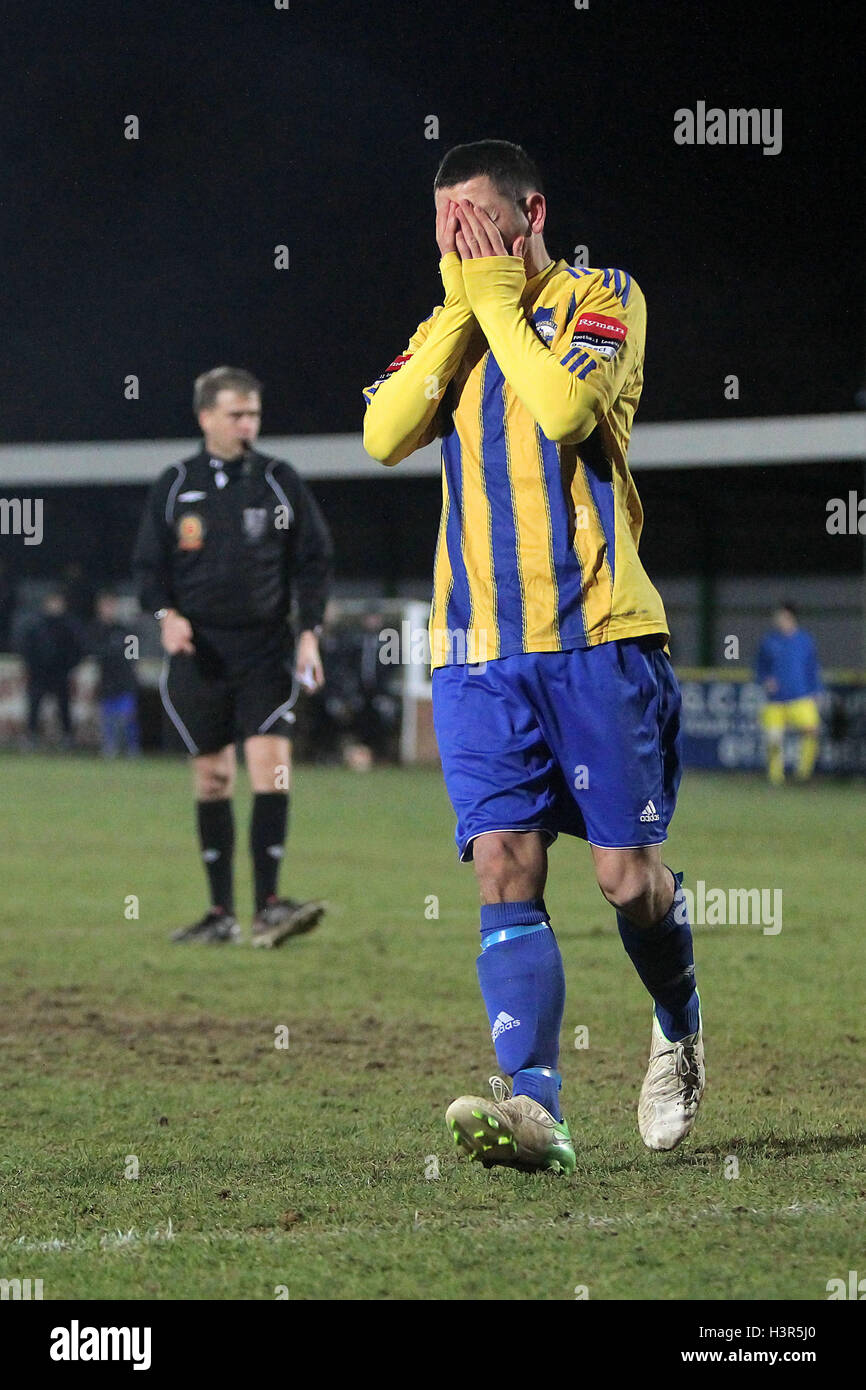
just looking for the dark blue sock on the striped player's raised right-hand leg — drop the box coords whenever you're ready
[616,870,701,1043]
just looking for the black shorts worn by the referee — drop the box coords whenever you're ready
[160,623,299,758]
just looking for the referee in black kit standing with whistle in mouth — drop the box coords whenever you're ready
[133,367,332,947]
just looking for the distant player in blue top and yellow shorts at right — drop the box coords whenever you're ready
[755,603,823,787]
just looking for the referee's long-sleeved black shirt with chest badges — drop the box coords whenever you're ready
[132,448,332,631]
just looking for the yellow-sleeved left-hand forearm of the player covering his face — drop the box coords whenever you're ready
[364,256,474,466]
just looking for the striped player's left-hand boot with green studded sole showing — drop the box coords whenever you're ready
[445,1076,577,1173]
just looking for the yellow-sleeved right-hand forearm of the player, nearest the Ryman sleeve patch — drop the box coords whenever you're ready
[463,256,612,443]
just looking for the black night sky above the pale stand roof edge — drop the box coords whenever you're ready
[0,0,866,441]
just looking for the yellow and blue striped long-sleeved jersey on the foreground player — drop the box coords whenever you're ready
[364,253,669,667]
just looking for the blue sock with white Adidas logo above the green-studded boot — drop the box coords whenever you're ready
[477,898,566,1120]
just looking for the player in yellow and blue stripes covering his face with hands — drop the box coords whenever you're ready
[364,140,703,1172]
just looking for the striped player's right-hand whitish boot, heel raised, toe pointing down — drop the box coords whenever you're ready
[638,1011,706,1150]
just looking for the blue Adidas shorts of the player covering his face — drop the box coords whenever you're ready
[432,637,681,859]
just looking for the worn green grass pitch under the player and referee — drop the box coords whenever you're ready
[0,756,866,1300]
